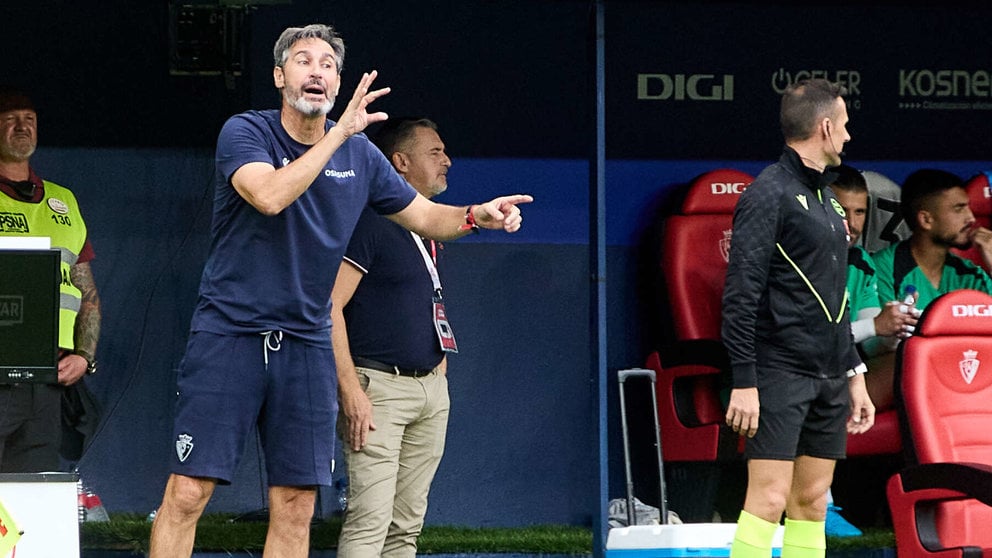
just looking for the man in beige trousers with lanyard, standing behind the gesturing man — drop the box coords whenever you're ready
[331,118,457,558]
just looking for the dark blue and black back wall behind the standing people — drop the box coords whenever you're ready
[0,0,992,525]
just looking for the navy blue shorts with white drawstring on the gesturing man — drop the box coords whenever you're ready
[171,331,338,486]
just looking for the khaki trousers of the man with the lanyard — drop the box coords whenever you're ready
[337,368,451,558]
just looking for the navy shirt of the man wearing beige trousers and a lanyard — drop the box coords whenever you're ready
[343,209,444,368]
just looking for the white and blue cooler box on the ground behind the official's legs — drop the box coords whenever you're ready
[606,523,784,558]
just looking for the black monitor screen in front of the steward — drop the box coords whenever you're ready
[0,250,62,383]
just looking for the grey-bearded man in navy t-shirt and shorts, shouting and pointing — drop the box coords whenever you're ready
[149,24,531,558]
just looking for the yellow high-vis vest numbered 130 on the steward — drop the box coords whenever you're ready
[0,180,86,350]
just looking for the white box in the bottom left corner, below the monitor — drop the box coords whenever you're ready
[0,473,79,558]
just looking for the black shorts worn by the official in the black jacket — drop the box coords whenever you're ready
[744,369,851,461]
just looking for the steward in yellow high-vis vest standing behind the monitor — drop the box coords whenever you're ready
[0,87,100,473]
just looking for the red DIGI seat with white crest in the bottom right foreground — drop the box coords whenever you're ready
[886,290,992,558]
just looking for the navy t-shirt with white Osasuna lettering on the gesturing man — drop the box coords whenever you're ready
[191,110,416,347]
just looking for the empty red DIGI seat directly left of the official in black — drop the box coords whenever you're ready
[646,169,754,461]
